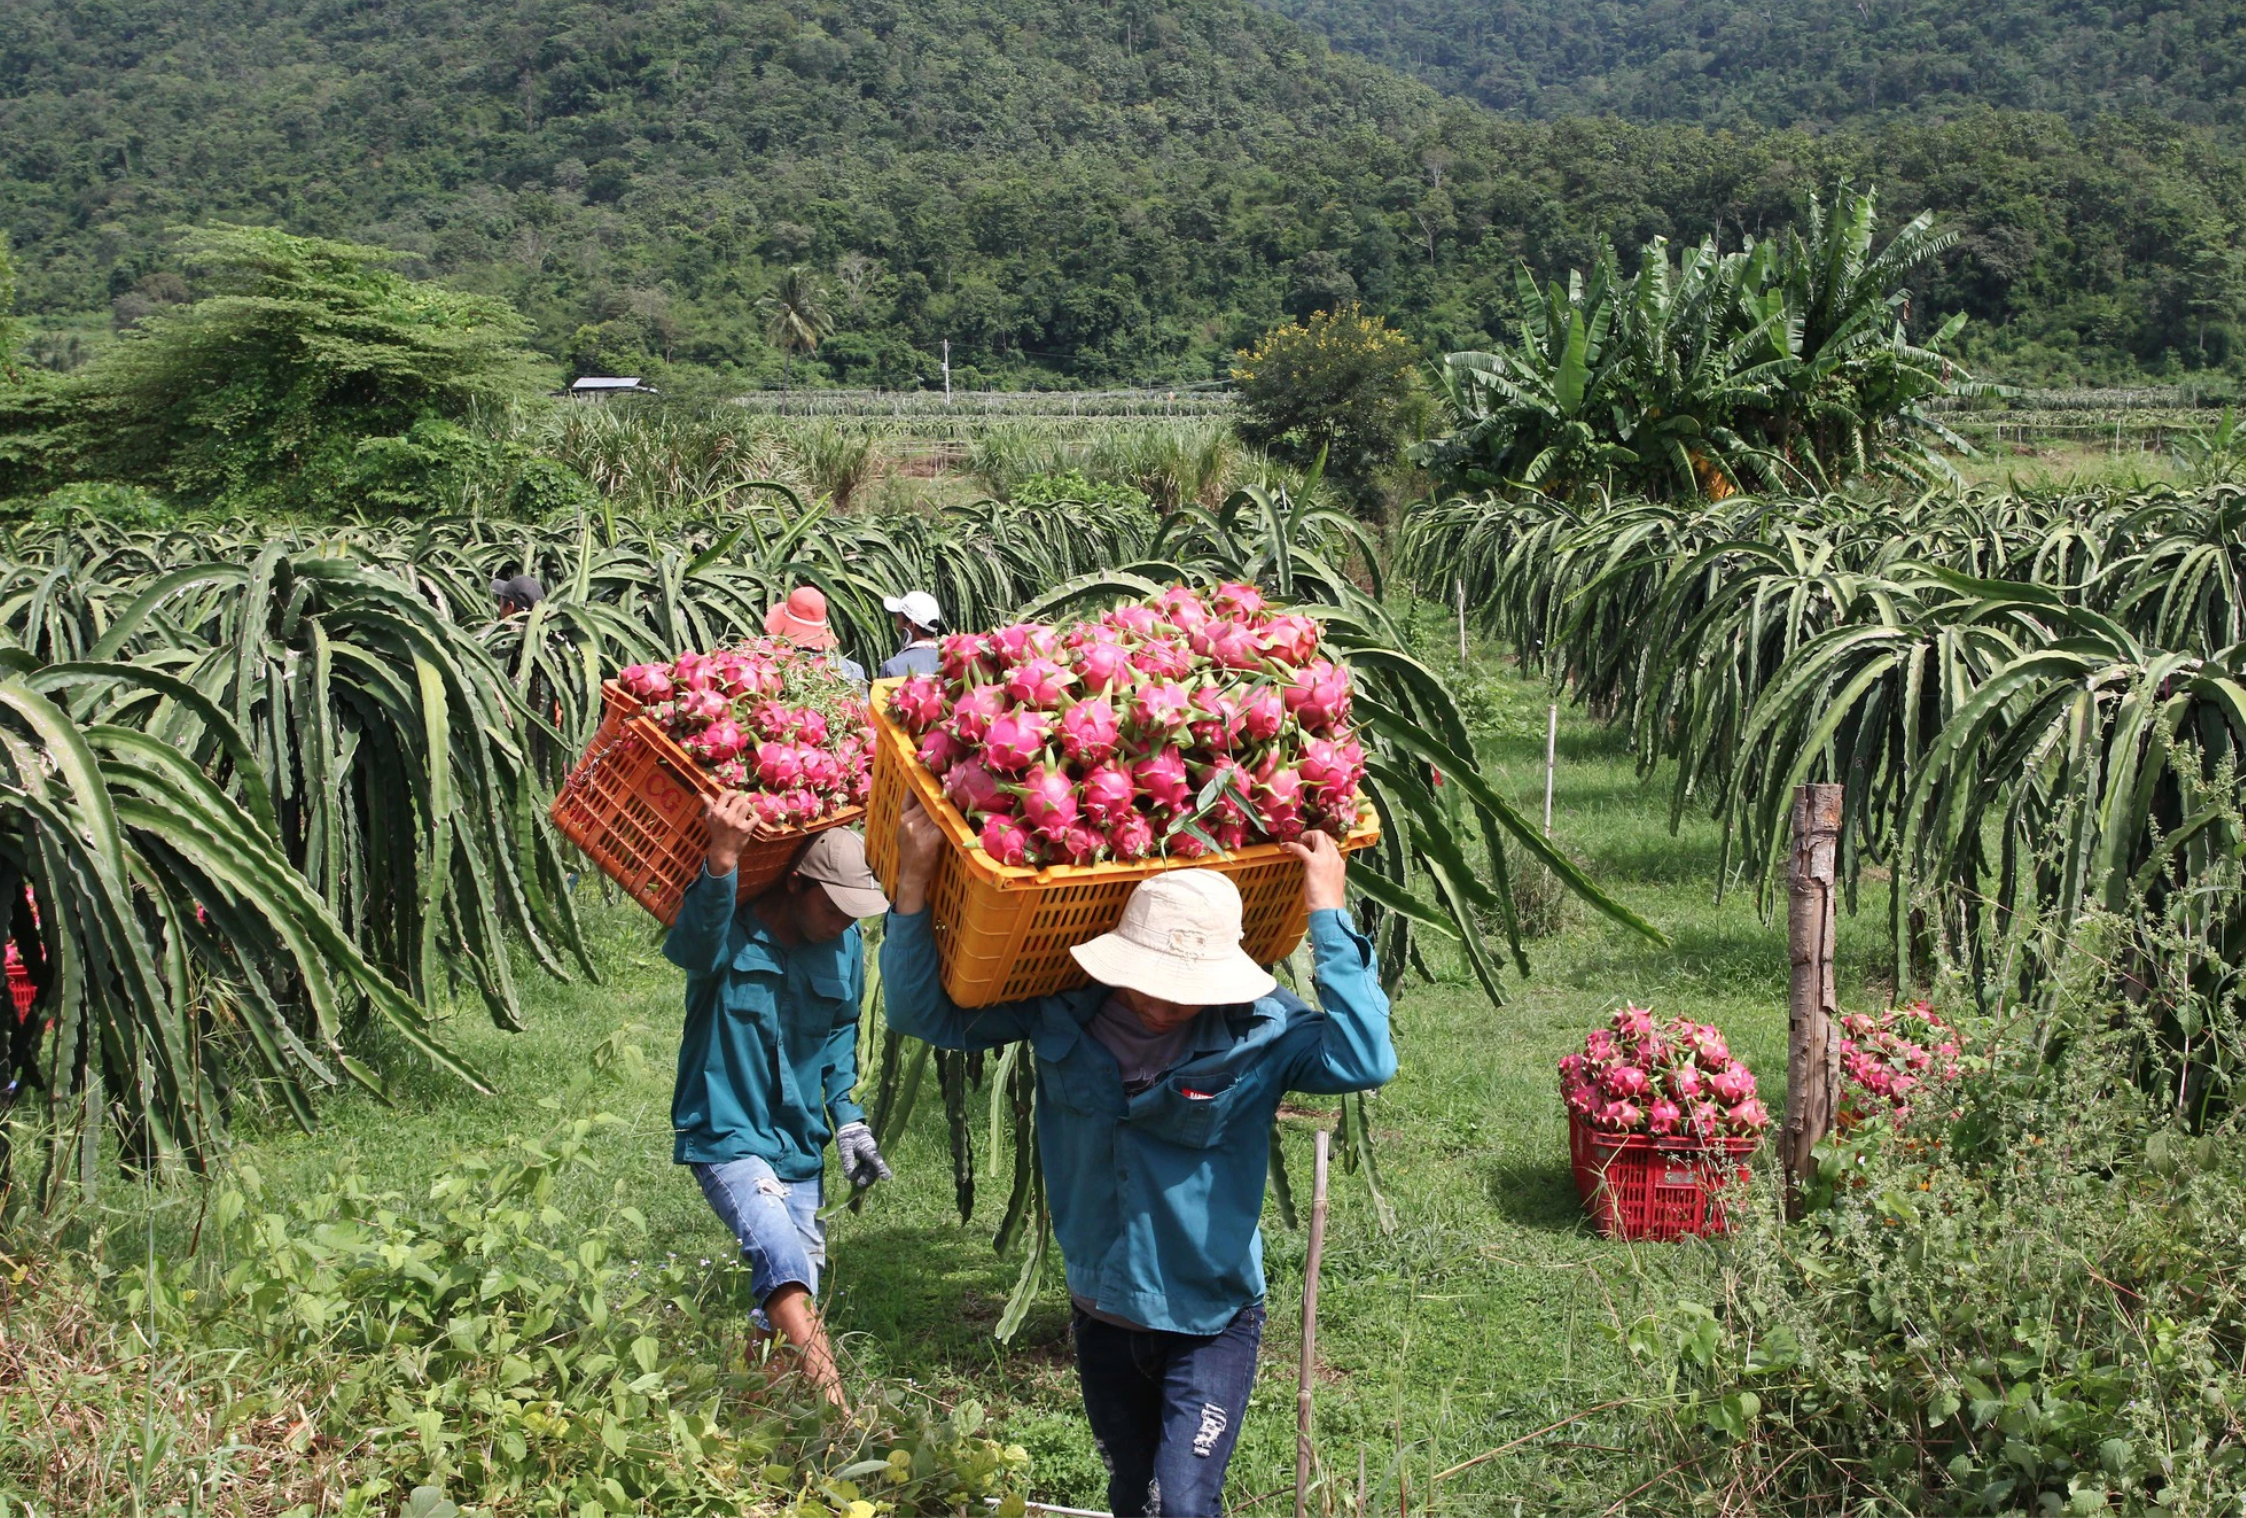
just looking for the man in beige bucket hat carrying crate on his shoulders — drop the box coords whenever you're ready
[880,802,1397,1518]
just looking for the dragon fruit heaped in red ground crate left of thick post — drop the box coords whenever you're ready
[1559,1006,1770,1139]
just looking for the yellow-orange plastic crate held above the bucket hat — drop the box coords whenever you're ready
[865,680,1381,1006]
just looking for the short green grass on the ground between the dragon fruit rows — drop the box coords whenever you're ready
[96,669,1884,1516]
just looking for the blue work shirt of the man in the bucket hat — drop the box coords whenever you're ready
[880,909,1397,1334]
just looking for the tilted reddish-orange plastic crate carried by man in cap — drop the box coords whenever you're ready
[553,683,865,927]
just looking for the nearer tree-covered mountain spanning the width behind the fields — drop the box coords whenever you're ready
[0,0,2246,386]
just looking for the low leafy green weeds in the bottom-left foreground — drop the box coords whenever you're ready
[0,1033,1026,1518]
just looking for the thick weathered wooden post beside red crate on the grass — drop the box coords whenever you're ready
[1779,786,1842,1213]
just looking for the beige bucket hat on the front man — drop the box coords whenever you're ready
[1069,869,1278,1006]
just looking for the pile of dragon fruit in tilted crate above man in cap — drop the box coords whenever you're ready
[615,638,874,829]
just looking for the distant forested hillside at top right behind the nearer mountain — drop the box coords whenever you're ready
[1271,0,2246,128]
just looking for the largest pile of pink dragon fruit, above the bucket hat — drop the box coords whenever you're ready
[889,584,1366,867]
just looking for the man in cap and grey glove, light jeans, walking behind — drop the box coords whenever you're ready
[663,790,889,1408]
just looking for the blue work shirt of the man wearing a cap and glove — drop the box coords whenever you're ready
[663,869,865,1181]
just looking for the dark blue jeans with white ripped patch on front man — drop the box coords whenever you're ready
[1074,1302,1264,1518]
